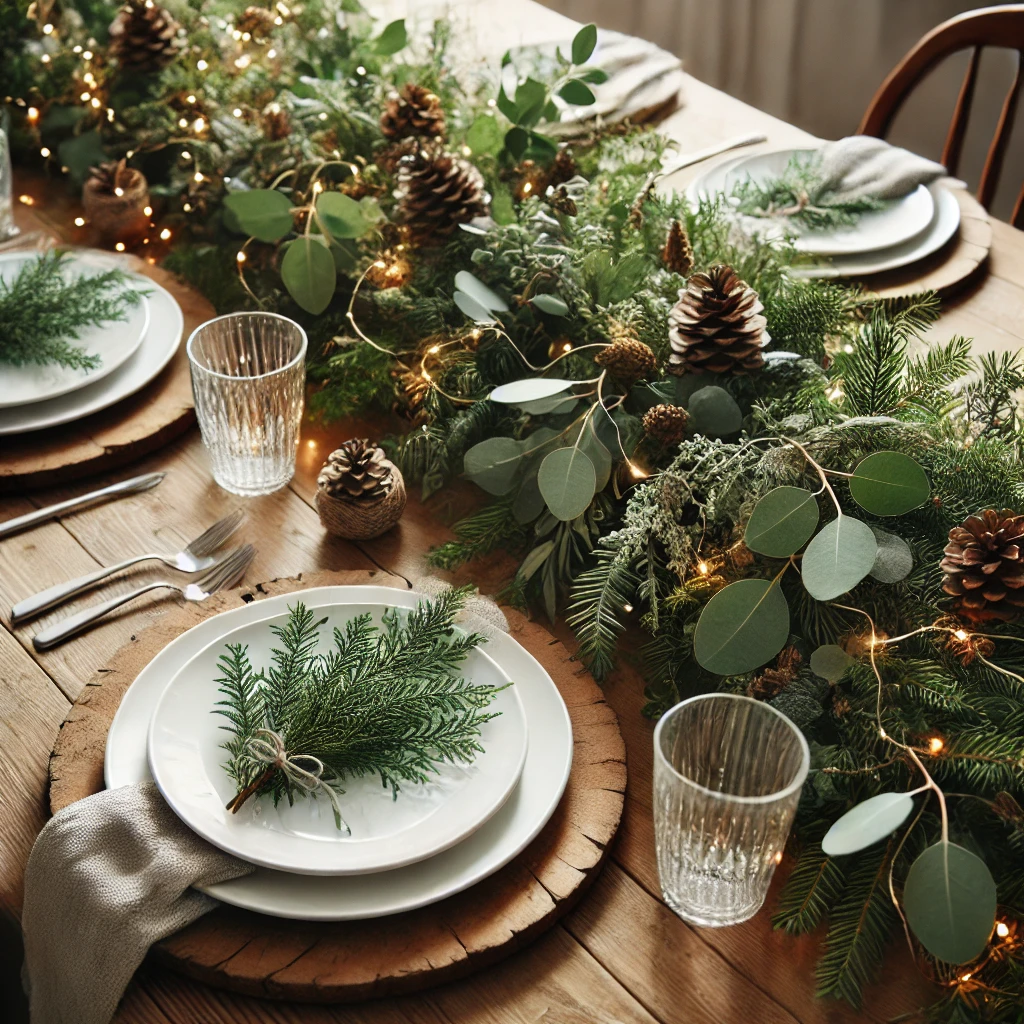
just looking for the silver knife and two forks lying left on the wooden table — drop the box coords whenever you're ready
[0,473,256,651]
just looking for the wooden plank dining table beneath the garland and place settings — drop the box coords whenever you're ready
[0,0,1024,1024]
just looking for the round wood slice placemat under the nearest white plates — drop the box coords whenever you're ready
[50,571,626,1002]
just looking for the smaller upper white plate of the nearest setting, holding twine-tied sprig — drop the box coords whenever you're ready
[150,595,526,876]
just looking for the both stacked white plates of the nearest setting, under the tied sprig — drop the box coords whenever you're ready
[112,587,572,921]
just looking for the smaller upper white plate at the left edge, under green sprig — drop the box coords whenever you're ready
[0,252,150,409]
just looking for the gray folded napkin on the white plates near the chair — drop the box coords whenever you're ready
[819,135,946,200]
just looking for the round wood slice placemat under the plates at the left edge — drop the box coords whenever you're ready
[0,200,211,493]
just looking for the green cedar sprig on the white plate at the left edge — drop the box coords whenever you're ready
[0,253,142,370]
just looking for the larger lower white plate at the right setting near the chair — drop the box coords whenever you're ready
[686,152,961,278]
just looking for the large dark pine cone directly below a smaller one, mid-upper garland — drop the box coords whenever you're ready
[398,153,487,246]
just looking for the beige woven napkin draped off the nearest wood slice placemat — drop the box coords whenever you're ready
[22,782,255,1024]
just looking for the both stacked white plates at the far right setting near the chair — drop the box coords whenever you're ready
[687,148,961,278]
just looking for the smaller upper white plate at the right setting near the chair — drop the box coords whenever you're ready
[718,148,935,256]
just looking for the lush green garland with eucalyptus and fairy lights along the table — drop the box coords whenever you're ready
[0,6,1024,1022]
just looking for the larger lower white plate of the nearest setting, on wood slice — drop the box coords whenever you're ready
[111,587,572,921]
